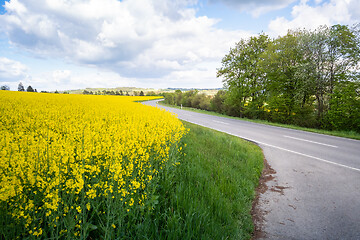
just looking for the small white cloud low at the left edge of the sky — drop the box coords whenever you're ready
[0,57,29,82]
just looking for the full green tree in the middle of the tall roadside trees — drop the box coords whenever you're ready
[262,31,310,123]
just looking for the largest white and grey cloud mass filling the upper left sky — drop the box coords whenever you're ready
[0,0,250,86]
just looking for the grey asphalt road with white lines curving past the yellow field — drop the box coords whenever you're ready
[144,101,360,240]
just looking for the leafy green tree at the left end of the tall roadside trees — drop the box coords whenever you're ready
[217,34,269,117]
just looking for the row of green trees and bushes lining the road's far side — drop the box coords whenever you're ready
[165,25,360,132]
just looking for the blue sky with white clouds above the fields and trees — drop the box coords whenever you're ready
[0,0,360,91]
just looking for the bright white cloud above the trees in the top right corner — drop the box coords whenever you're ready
[269,0,360,36]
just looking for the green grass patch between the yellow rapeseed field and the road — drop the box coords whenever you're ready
[141,122,263,239]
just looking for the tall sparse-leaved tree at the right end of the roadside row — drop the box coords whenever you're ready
[303,25,360,126]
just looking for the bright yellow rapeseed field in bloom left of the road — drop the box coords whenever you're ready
[0,91,186,239]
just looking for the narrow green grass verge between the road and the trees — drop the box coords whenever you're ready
[158,102,360,140]
